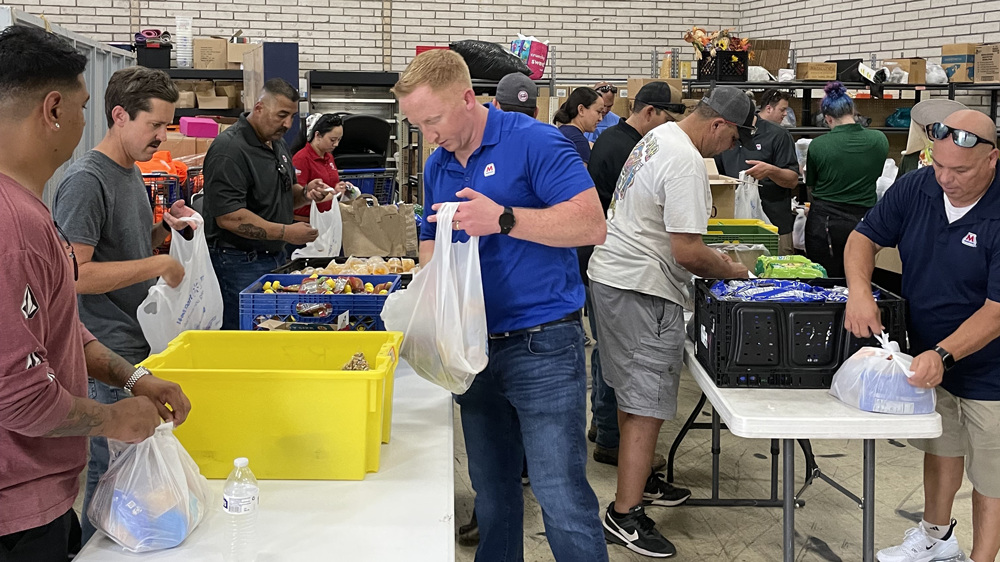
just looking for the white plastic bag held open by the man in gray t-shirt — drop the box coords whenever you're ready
[136,213,222,353]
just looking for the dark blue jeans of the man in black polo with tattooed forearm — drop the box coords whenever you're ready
[209,247,286,330]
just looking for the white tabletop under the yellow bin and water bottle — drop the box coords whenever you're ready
[76,362,455,562]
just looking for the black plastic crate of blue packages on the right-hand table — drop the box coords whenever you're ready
[693,279,907,388]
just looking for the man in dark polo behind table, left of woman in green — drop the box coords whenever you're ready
[715,93,799,255]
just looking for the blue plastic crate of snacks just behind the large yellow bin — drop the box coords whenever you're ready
[240,274,400,331]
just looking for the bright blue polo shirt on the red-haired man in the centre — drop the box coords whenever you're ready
[420,106,594,333]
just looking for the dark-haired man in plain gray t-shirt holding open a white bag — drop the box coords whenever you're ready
[52,66,194,542]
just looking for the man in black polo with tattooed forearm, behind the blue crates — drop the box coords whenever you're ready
[204,78,327,330]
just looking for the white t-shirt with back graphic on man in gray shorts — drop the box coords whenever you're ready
[588,123,712,310]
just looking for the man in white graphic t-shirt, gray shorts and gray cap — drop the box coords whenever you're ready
[589,86,755,558]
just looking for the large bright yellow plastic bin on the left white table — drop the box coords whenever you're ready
[142,331,403,480]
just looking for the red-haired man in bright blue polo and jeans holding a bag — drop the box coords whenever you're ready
[393,50,608,562]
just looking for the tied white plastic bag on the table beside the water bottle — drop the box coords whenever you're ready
[87,423,213,553]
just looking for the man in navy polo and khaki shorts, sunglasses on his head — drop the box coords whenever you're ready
[844,110,1000,562]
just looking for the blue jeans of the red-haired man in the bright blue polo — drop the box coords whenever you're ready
[456,322,608,562]
